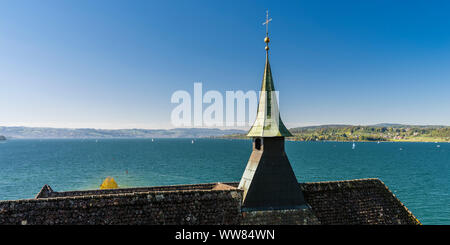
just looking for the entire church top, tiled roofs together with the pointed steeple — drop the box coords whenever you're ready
[0,16,420,225]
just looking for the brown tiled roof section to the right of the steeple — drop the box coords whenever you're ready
[300,179,420,225]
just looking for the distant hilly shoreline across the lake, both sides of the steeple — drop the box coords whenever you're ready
[0,123,450,143]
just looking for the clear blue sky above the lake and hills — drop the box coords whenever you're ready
[0,0,450,128]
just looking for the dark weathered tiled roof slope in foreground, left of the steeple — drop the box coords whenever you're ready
[0,190,242,225]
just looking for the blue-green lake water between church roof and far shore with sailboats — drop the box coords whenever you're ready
[0,139,450,225]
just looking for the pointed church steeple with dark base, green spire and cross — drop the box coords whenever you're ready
[238,11,308,211]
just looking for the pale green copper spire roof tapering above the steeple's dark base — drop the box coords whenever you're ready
[247,51,292,137]
